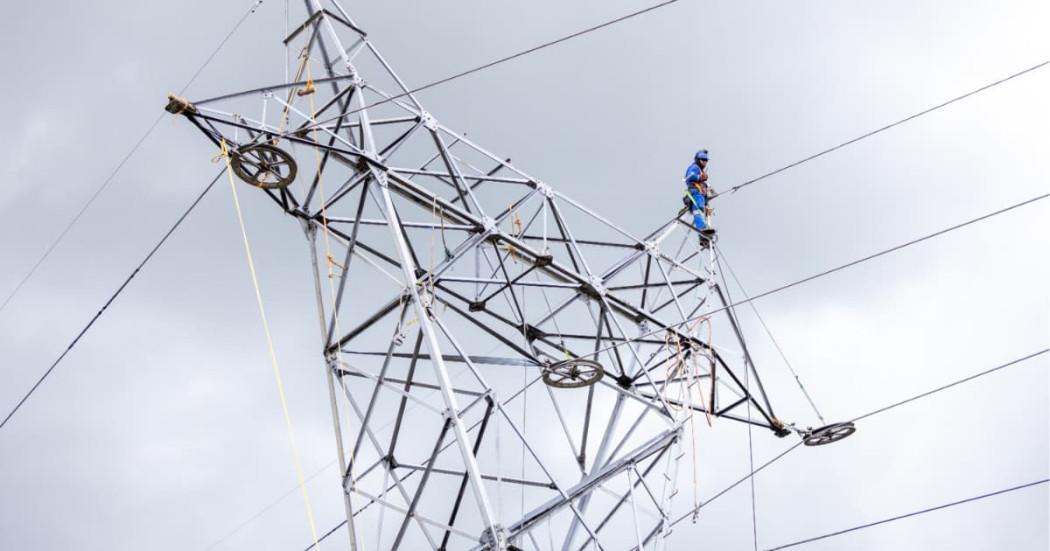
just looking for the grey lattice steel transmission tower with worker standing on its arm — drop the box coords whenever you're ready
[168,0,844,550]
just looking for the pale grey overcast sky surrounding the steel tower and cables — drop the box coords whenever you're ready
[0,0,1050,550]
